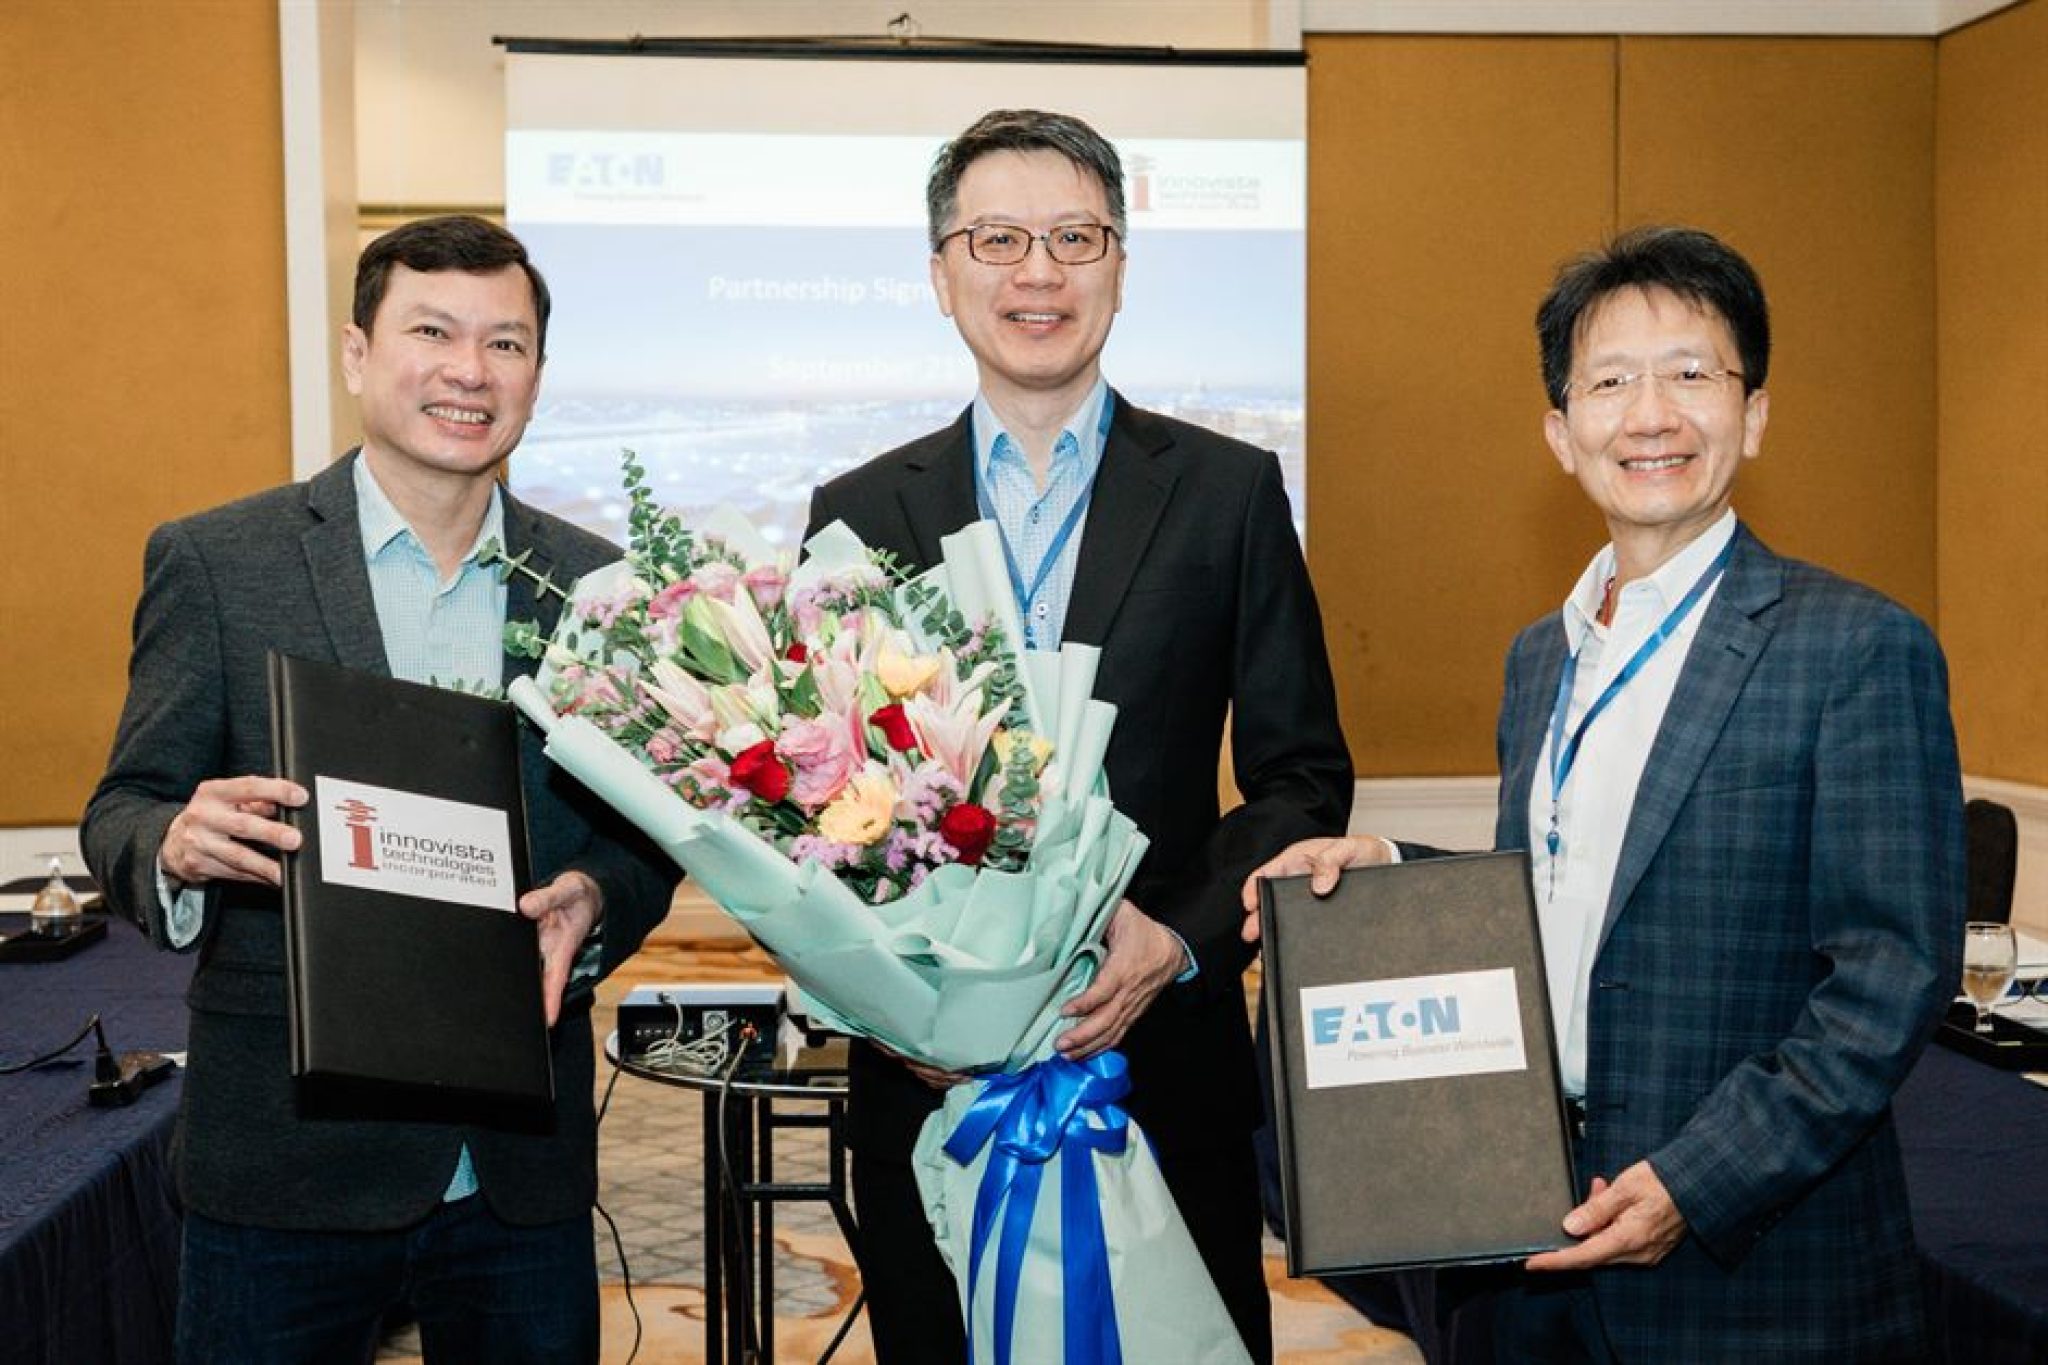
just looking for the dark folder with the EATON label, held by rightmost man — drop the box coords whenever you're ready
[1260,853,1577,1275]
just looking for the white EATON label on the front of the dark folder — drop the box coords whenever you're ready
[1300,968,1528,1091]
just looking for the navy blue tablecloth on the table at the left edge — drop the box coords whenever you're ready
[0,915,193,1365]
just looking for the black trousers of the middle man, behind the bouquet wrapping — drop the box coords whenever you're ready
[854,1134,1274,1365]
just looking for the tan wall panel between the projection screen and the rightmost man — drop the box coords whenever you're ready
[1309,37,1614,778]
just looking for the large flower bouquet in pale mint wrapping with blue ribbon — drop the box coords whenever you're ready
[508,454,1245,1363]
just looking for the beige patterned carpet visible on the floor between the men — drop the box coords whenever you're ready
[379,921,1421,1365]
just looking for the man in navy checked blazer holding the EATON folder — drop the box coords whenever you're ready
[1245,227,1964,1365]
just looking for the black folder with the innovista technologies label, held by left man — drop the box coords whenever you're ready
[270,653,553,1107]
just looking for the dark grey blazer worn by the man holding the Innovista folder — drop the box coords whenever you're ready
[80,458,676,1230]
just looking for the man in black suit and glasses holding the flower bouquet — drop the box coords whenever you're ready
[811,111,1352,1365]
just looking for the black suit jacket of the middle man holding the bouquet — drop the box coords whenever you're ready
[811,397,1352,1160]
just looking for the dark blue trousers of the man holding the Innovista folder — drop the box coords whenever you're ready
[178,1195,598,1365]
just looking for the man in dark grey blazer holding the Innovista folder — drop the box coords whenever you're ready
[82,217,674,1365]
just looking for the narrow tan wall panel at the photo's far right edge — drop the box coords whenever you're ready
[1935,0,2048,784]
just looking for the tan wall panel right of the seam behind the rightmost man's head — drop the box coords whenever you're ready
[1618,39,1935,620]
